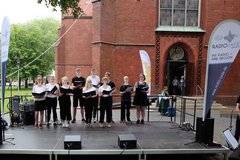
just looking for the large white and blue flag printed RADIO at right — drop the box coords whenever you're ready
[203,20,240,120]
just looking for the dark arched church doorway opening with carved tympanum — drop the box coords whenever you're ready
[167,44,189,95]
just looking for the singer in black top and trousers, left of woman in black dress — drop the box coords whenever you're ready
[120,76,133,122]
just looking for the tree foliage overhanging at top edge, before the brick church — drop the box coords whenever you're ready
[38,0,83,18]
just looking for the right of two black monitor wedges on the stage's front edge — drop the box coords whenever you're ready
[118,134,137,149]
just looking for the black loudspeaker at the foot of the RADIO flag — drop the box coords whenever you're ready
[195,117,214,144]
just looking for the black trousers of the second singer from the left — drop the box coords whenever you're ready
[46,97,57,122]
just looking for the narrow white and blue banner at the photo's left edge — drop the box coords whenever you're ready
[1,17,10,113]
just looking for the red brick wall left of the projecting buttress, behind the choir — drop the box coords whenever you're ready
[55,0,93,80]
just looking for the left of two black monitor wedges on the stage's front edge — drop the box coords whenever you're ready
[64,135,82,149]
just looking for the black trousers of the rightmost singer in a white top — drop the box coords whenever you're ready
[99,97,112,123]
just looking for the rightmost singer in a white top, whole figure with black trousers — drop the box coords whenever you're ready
[98,77,112,128]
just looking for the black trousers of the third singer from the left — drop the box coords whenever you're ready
[59,95,72,121]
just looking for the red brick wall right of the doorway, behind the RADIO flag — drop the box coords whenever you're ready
[202,0,240,104]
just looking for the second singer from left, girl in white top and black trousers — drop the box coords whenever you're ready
[46,76,59,127]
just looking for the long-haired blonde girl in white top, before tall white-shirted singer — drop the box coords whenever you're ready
[83,79,97,127]
